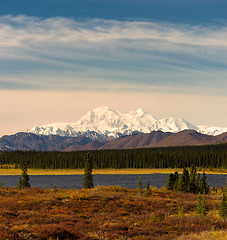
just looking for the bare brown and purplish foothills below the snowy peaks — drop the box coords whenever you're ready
[0,130,227,151]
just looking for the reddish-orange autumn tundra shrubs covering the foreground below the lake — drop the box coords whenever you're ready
[0,186,227,240]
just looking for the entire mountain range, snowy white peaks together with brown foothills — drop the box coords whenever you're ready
[0,107,227,151]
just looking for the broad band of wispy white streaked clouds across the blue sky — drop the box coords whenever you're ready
[0,15,227,94]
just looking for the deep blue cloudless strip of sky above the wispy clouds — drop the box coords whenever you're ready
[0,0,227,24]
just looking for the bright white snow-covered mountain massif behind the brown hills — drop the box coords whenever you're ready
[28,106,227,141]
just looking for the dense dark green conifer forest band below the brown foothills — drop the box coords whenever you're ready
[0,144,227,169]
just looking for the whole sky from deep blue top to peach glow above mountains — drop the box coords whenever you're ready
[0,0,227,135]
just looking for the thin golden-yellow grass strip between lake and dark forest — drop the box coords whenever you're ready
[0,168,227,175]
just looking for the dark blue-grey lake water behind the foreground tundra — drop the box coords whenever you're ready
[0,173,227,189]
